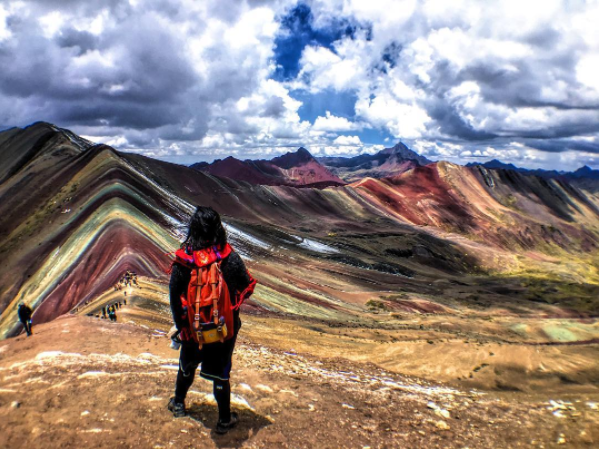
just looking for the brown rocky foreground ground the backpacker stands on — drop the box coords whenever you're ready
[0,316,598,448]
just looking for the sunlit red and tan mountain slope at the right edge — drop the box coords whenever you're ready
[352,162,598,270]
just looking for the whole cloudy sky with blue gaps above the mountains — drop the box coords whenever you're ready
[0,0,600,169]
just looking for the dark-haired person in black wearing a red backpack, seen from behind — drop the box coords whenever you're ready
[168,207,256,433]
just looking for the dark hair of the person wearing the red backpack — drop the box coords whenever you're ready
[181,206,227,251]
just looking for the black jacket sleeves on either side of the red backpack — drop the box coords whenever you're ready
[169,251,251,333]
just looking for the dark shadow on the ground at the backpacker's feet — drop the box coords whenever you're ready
[188,403,271,447]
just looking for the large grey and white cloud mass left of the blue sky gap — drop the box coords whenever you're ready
[0,0,298,151]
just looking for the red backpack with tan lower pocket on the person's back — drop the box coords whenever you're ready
[175,244,234,347]
